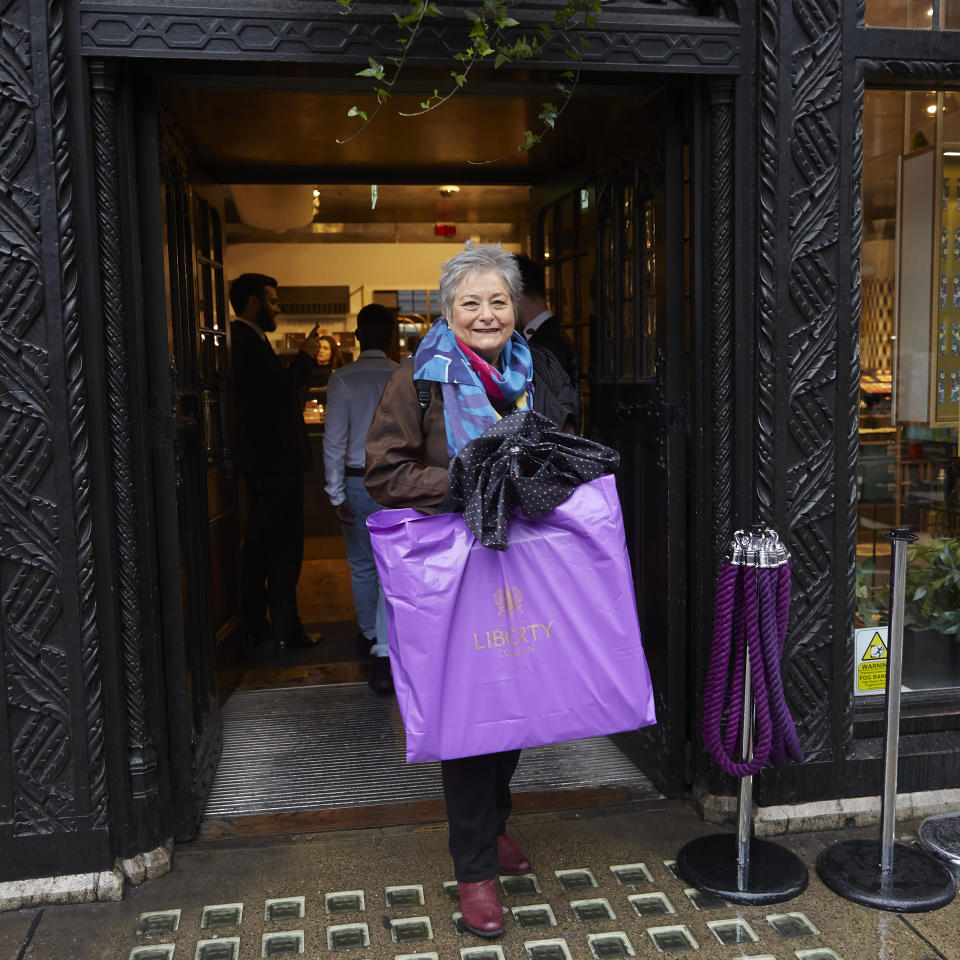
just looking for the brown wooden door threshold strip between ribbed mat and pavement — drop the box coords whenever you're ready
[197,787,651,841]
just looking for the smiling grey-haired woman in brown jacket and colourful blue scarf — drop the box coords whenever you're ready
[366,245,576,937]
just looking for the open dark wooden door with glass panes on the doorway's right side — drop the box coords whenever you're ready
[538,92,691,794]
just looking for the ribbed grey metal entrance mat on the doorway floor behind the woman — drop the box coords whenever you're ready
[204,683,660,819]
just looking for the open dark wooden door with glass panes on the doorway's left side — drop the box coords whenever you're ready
[138,105,241,840]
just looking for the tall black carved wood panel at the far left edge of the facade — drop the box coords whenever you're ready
[0,0,108,840]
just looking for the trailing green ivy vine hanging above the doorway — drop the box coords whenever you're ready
[337,0,601,163]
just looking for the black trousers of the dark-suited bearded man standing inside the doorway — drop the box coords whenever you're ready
[240,470,303,643]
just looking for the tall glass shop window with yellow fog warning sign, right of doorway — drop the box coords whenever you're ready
[854,90,960,696]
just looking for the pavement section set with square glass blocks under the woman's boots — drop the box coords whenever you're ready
[124,861,844,960]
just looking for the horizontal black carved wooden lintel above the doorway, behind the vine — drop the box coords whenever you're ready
[80,0,741,72]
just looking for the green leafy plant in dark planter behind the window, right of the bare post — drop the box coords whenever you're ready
[903,537,960,688]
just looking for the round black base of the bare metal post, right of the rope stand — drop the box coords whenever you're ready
[817,840,957,913]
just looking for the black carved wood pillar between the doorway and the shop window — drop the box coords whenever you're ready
[755,0,855,760]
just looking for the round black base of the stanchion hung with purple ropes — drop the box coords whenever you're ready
[677,833,809,903]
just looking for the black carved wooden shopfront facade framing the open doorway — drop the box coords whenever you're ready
[0,0,960,879]
